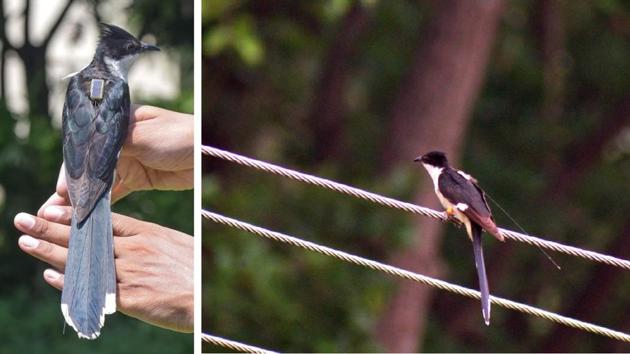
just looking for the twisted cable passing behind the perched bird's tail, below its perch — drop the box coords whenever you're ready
[201,210,630,342]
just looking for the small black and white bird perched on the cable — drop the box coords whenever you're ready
[414,151,504,325]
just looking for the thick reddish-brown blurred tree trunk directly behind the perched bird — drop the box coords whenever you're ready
[376,0,503,352]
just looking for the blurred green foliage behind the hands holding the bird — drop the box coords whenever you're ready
[0,0,193,353]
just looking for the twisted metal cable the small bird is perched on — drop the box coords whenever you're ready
[201,146,630,270]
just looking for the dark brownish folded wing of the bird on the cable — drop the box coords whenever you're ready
[438,168,502,239]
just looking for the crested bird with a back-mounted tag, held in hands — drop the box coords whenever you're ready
[61,24,159,339]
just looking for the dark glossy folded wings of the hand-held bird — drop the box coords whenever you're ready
[62,74,130,222]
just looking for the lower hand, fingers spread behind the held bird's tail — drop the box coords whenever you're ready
[14,206,194,332]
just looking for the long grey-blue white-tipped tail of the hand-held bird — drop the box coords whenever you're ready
[61,193,116,339]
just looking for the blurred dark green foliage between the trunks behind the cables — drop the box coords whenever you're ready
[202,0,630,352]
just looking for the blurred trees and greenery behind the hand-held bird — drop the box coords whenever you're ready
[0,0,193,353]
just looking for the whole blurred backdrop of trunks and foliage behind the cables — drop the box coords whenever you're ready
[202,0,630,352]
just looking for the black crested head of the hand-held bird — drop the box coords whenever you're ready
[96,23,160,78]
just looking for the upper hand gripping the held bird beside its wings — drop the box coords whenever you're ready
[37,105,194,213]
